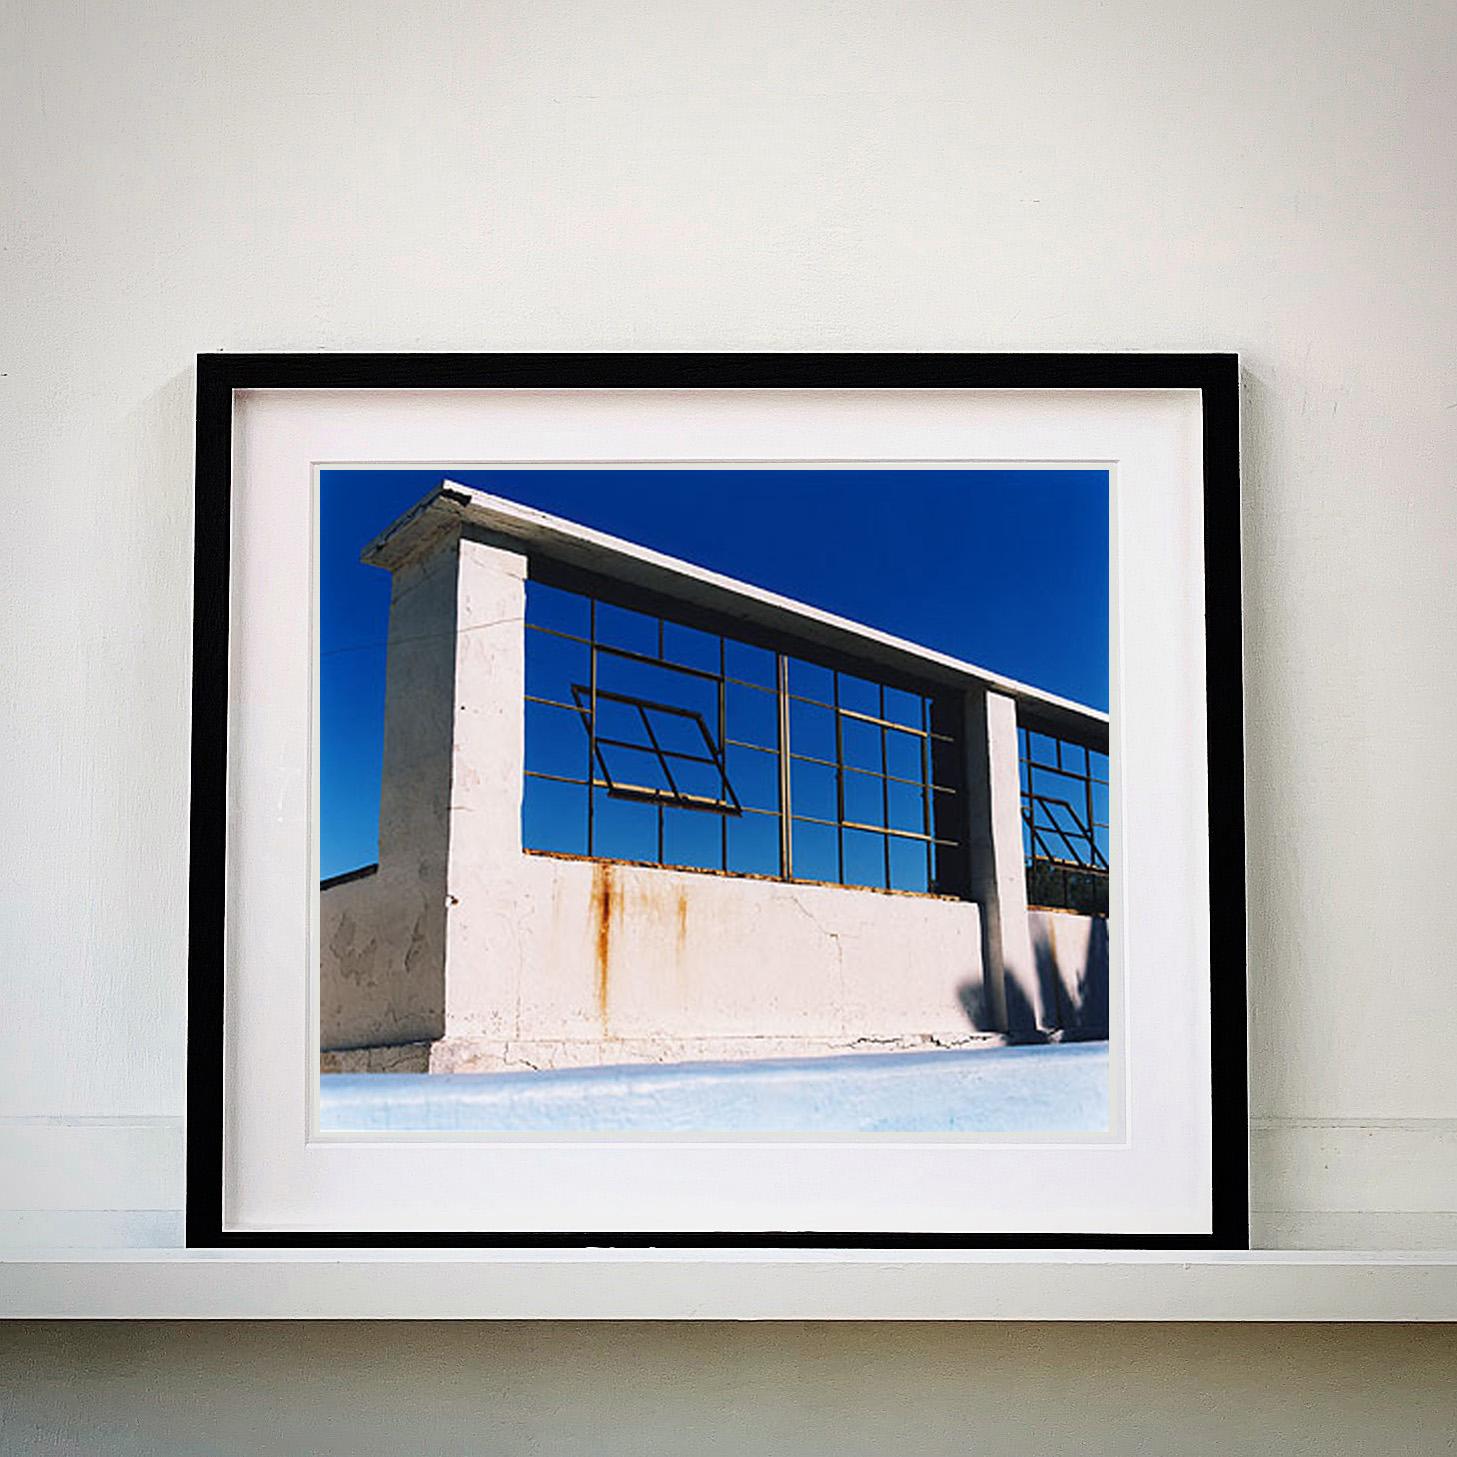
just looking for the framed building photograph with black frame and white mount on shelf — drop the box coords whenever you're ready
[186,354,1247,1249]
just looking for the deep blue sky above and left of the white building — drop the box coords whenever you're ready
[319,469,1109,876]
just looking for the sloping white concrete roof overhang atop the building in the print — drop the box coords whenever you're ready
[360,481,1109,752]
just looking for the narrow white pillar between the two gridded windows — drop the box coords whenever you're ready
[966,689,1052,1037]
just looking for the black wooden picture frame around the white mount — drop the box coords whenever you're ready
[186,354,1249,1249]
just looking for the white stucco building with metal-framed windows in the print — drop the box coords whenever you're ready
[321,482,1107,1071]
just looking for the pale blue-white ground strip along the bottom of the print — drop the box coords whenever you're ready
[321,1042,1109,1134]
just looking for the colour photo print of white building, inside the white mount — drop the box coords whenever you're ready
[319,466,1112,1134]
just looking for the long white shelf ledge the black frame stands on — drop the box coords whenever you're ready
[0,1250,1457,1321]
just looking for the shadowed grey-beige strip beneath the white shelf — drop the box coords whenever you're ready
[0,1323,1457,1457]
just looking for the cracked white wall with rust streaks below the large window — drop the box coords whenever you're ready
[431,855,982,1072]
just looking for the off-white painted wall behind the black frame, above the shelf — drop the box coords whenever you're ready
[0,0,1457,1433]
